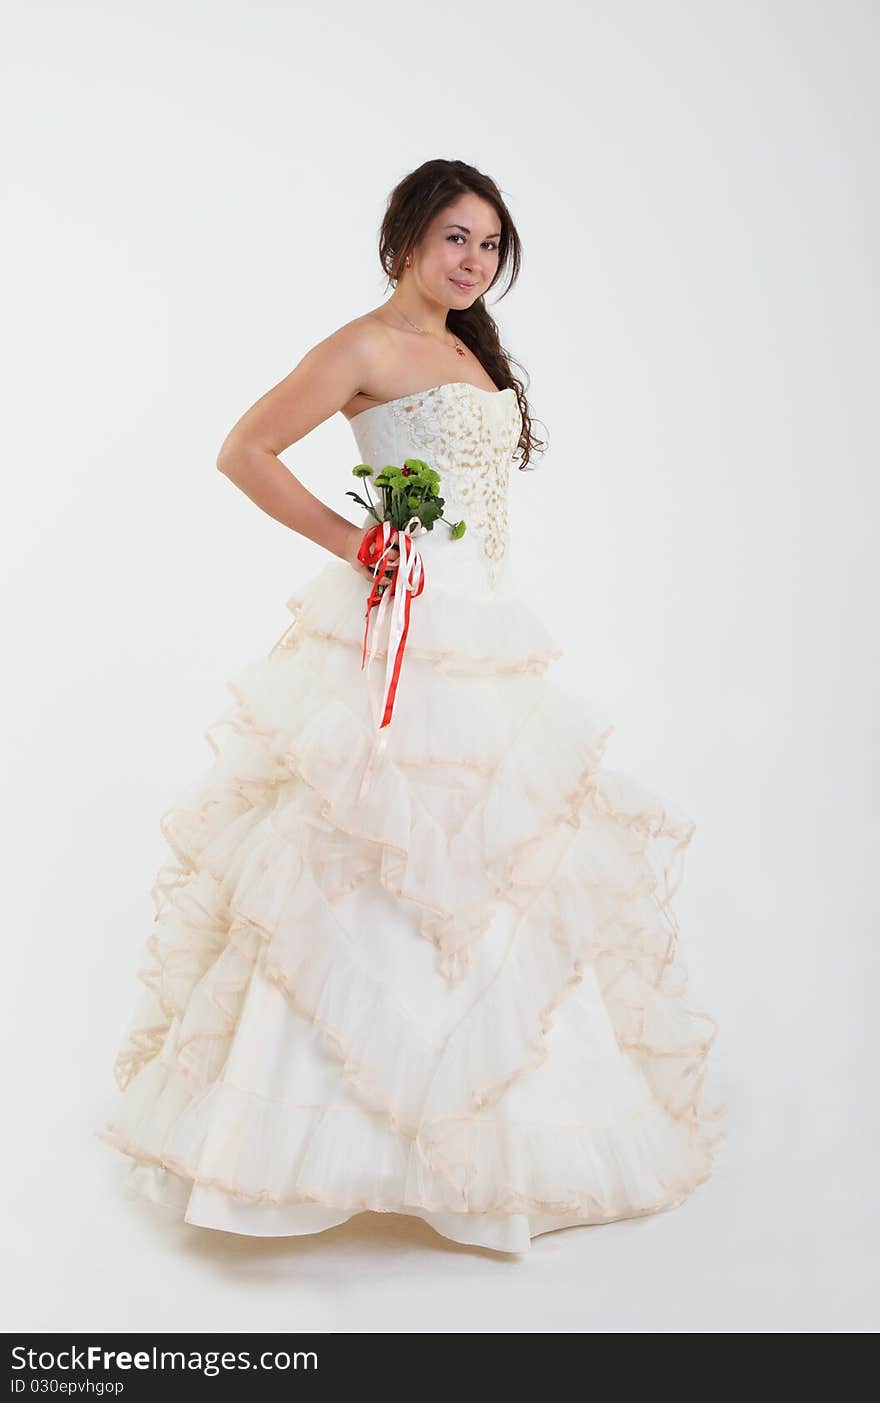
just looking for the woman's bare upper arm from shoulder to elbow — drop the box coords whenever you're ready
[218,311,393,463]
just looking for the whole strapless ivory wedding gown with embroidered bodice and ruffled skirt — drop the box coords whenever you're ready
[95,382,721,1253]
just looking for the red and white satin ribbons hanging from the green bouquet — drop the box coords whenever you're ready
[358,516,425,730]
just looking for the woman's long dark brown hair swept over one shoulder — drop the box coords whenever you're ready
[379,160,546,471]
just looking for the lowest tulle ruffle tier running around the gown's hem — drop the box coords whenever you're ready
[100,1038,710,1222]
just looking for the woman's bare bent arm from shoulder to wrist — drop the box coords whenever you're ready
[218,321,392,579]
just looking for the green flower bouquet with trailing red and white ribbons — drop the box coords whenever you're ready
[345,457,465,728]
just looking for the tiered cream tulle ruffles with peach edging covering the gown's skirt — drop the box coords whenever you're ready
[100,567,720,1251]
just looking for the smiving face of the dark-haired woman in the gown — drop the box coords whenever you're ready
[407,192,501,307]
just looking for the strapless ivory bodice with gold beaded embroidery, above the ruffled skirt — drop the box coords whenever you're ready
[349,382,522,595]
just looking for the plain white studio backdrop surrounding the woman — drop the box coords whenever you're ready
[3,0,880,1333]
